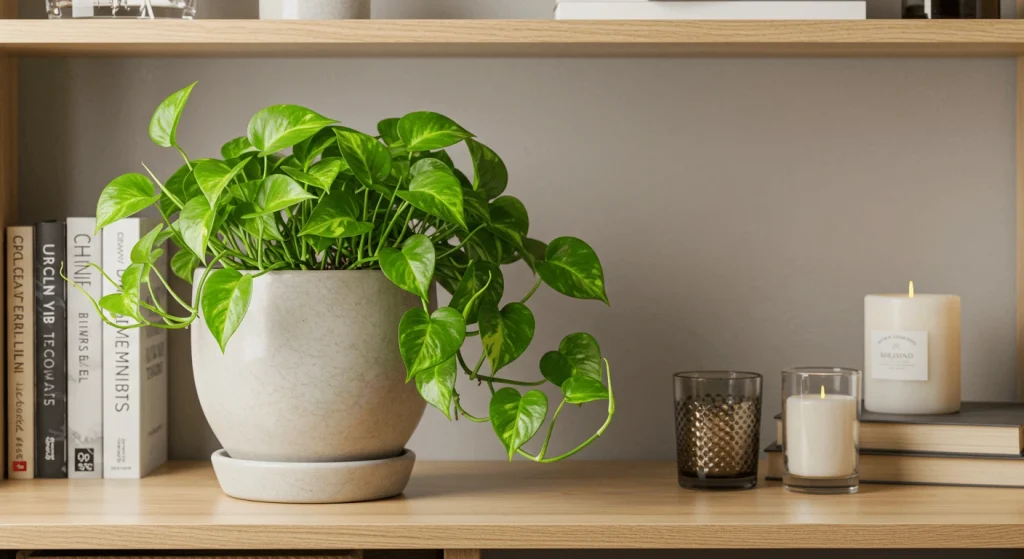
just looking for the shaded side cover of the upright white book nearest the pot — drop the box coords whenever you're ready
[139,219,168,476]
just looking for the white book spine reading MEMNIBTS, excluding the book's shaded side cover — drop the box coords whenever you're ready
[102,218,141,479]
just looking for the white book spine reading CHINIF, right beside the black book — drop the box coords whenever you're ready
[67,218,103,478]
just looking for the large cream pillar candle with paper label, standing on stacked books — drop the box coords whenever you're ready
[864,283,961,414]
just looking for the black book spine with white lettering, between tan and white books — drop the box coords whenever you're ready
[36,221,68,478]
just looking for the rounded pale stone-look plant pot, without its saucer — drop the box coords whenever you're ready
[191,270,426,463]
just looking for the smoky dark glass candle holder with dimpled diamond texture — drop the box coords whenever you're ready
[674,371,762,489]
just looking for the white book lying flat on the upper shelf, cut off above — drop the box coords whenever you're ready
[555,0,867,19]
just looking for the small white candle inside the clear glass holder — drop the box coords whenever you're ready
[783,389,857,477]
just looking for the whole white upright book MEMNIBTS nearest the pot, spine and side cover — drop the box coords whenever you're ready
[102,218,167,479]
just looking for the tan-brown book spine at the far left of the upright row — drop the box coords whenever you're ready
[7,226,36,479]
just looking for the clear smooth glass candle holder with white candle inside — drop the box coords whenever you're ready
[782,368,861,493]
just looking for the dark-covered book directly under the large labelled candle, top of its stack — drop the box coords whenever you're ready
[775,401,1024,457]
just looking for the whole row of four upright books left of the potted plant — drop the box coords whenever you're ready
[6,218,167,479]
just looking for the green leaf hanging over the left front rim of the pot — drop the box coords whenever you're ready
[202,268,253,352]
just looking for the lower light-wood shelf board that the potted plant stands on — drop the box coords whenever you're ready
[6,462,1024,550]
